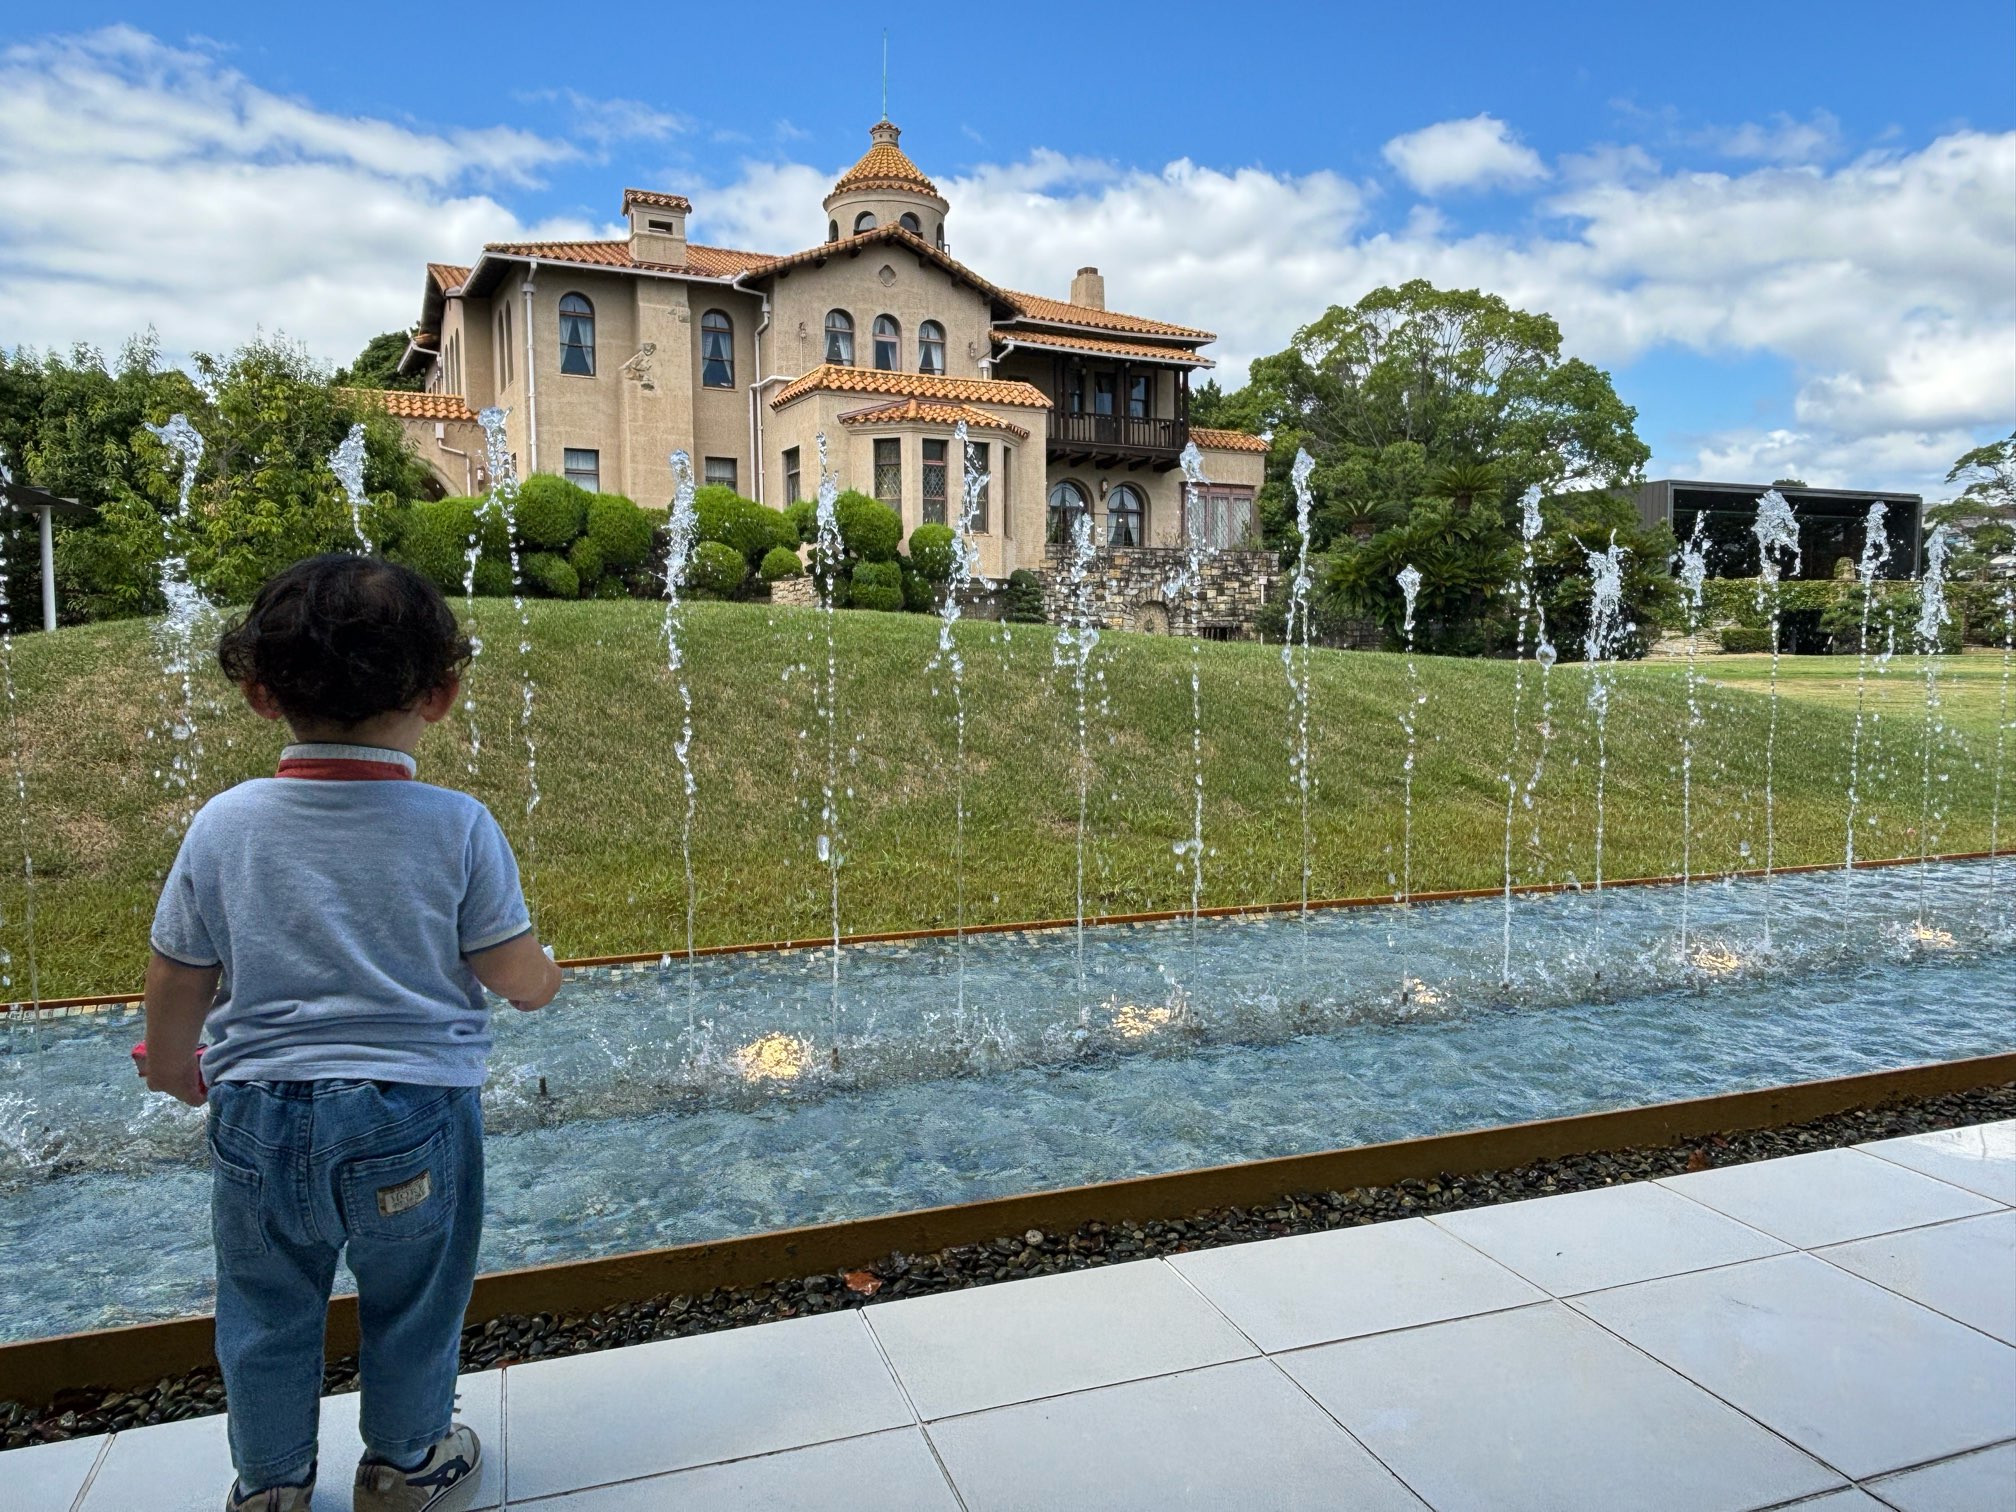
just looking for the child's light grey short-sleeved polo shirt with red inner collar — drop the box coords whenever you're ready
[153,746,532,1087]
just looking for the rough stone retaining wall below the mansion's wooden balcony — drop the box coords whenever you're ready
[1038,546,1280,641]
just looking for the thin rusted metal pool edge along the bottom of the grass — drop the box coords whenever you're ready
[0,849,2016,1018]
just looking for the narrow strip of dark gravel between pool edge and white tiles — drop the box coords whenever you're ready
[0,1083,2016,1450]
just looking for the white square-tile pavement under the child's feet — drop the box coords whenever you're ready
[0,1123,2016,1512]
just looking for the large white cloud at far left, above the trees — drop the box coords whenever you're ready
[0,26,589,361]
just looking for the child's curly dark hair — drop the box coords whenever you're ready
[218,554,470,726]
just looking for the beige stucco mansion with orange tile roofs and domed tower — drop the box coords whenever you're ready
[383,121,1266,592]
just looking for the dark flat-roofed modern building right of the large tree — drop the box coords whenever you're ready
[1639,478,1925,579]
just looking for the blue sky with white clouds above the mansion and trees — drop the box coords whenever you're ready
[0,0,2016,492]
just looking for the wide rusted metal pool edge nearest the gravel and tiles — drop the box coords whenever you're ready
[0,1050,2016,1407]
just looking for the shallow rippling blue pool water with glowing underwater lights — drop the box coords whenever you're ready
[0,861,2016,1339]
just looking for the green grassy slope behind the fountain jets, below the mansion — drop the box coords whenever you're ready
[0,603,2002,996]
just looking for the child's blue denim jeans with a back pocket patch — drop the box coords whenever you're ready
[210,1081,484,1492]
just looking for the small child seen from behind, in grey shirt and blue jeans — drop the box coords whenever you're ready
[143,556,560,1512]
